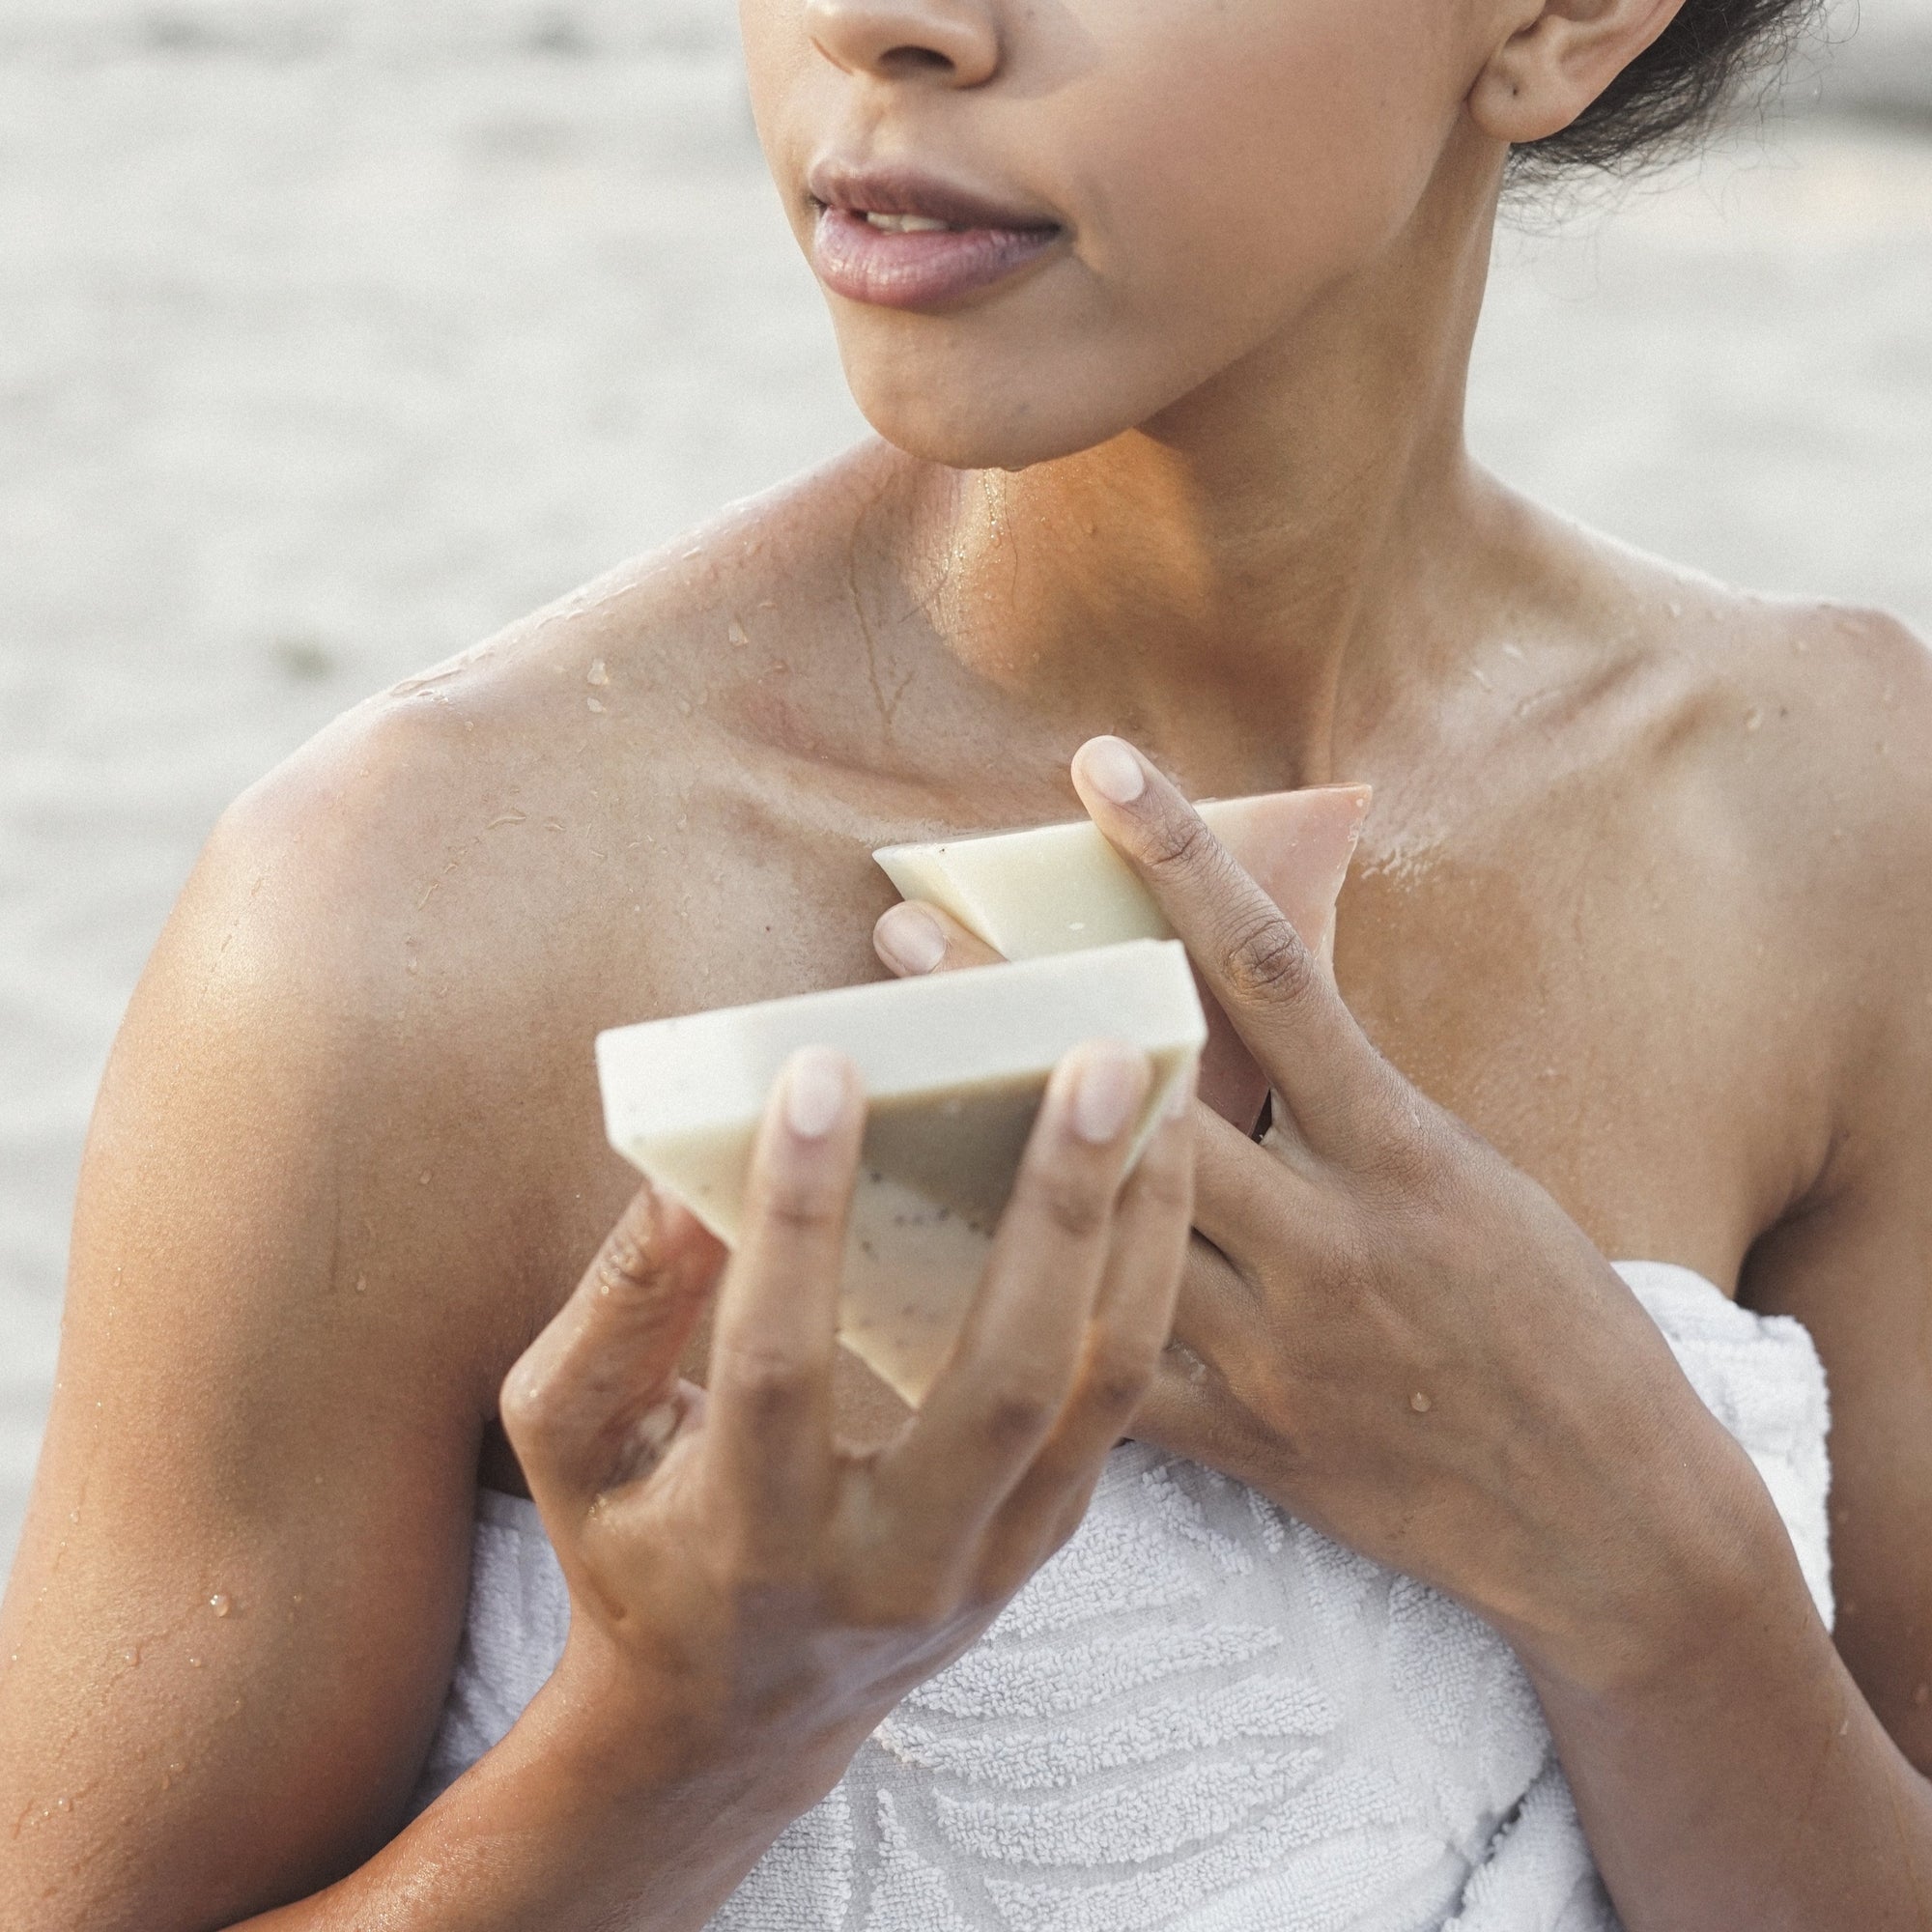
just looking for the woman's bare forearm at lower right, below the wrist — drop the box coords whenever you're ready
[1524,1497,1932,1932]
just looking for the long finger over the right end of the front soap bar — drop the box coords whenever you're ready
[881,1039,1151,1546]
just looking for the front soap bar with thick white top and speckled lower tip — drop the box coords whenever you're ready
[597,941,1208,1403]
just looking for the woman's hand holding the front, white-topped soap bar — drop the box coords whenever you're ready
[502,1041,1192,1810]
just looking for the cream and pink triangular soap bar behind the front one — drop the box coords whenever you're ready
[873,784,1370,1132]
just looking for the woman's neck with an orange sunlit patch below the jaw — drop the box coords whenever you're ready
[896,138,1493,788]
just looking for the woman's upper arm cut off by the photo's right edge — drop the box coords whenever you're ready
[1743,620,1932,1774]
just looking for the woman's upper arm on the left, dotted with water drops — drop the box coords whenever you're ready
[0,757,514,1932]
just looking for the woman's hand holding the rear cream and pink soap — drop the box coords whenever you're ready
[877,738,1768,1687]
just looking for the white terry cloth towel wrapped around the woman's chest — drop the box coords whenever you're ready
[417,1262,1832,1932]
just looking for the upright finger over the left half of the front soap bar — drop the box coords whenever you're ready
[705,1047,866,1528]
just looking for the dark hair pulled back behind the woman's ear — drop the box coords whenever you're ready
[1511,0,1824,182]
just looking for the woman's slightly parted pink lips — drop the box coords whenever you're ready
[811,170,1065,309]
